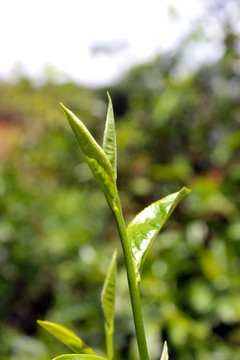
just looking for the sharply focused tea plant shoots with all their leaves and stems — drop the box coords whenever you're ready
[38,94,189,360]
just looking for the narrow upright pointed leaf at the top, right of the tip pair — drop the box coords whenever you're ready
[103,93,117,179]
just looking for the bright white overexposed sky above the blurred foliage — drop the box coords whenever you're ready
[0,0,206,85]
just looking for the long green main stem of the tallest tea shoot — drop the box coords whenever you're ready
[113,197,149,360]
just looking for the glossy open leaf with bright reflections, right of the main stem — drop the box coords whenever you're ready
[127,188,190,277]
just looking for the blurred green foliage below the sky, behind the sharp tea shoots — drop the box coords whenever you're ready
[0,4,240,360]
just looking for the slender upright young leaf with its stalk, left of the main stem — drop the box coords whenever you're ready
[101,249,117,360]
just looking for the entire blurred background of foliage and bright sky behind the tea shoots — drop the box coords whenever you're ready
[0,0,240,360]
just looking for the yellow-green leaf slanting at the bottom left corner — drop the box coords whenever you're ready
[37,320,95,354]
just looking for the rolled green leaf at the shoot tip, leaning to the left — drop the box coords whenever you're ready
[60,104,116,209]
